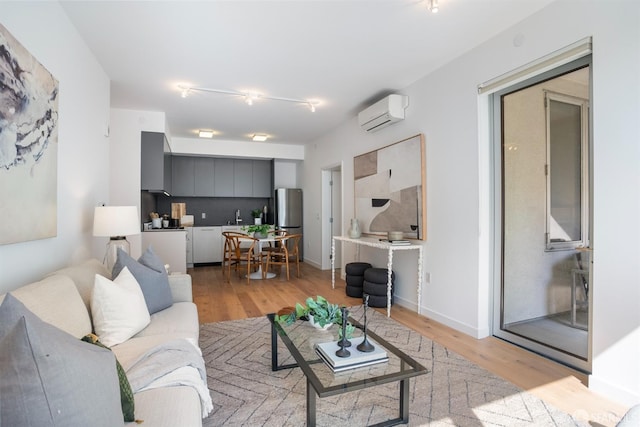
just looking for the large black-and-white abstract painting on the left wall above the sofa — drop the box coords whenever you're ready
[0,25,58,244]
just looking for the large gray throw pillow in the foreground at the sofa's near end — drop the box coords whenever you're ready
[0,294,124,427]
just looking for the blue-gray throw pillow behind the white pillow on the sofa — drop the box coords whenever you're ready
[111,247,173,314]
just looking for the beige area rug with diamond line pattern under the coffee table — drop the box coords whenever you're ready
[200,307,585,427]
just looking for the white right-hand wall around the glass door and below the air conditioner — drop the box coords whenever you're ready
[304,0,640,403]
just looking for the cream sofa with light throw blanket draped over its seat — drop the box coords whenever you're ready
[0,259,211,427]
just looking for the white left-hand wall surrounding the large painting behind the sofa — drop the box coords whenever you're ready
[0,2,110,294]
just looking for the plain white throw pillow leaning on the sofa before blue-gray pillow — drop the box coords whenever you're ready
[91,267,151,347]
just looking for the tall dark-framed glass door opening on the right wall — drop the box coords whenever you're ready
[490,55,593,372]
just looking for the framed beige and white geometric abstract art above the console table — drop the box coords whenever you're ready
[353,134,427,240]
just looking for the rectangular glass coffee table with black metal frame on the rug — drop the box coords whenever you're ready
[267,313,427,427]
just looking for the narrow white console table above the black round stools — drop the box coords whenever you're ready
[331,236,422,317]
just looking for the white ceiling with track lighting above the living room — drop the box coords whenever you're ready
[61,0,552,143]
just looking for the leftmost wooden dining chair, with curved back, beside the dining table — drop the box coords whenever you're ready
[222,231,265,283]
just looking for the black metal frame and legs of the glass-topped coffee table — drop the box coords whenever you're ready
[267,313,427,427]
